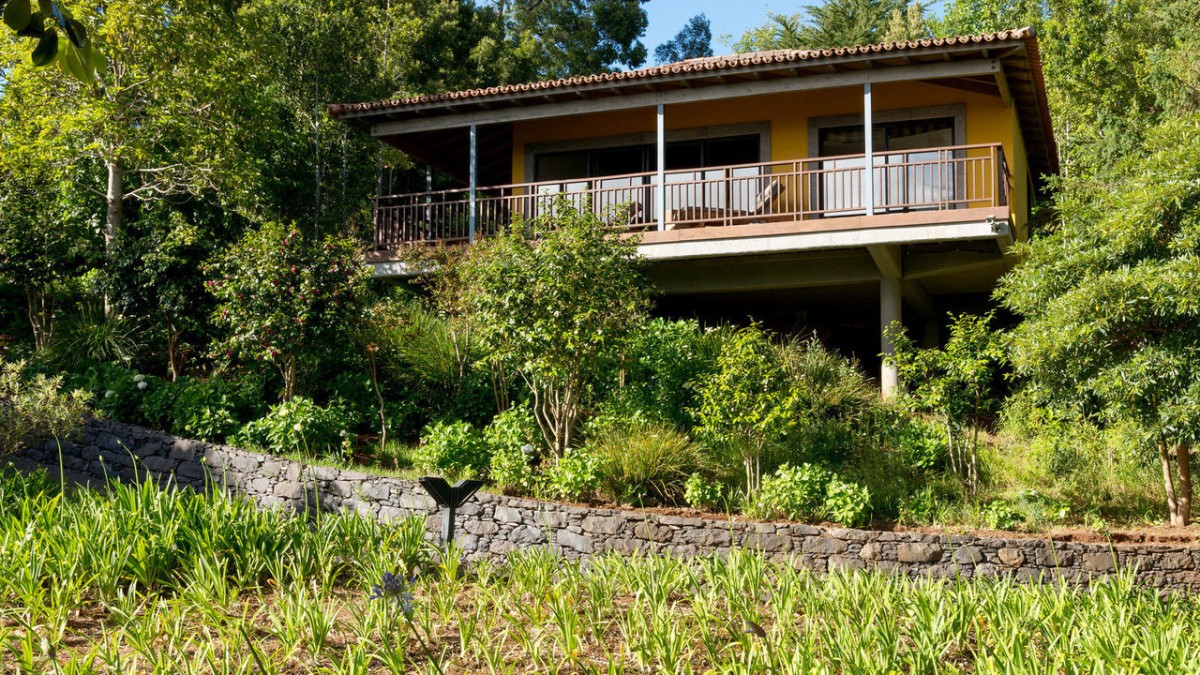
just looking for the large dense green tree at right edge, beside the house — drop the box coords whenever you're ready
[997,114,1200,526]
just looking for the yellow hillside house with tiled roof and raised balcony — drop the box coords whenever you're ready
[329,29,1058,392]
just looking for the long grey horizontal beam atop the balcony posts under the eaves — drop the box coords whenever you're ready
[371,59,1001,136]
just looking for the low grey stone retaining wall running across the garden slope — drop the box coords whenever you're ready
[14,420,1200,591]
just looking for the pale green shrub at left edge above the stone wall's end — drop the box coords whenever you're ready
[0,359,88,456]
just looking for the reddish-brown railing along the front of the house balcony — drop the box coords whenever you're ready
[374,144,1012,250]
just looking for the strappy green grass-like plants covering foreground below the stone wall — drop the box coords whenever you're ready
[0,466,1200,674]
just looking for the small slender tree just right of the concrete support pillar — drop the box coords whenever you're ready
[886,313,1007,495]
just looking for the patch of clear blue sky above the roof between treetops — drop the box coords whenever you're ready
[642,0,941,59]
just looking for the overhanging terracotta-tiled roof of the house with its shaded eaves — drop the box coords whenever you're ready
[329,29,1058,184]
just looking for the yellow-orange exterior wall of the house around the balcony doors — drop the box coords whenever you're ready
[512,82,1028,233]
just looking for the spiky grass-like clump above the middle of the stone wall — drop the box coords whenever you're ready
[590,423,703,503]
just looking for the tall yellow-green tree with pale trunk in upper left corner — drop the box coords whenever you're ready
[0,0,262,263]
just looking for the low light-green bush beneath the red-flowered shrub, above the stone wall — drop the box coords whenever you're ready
[234,396,350,455]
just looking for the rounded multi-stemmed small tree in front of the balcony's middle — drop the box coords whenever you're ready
[458,202,649,456]
